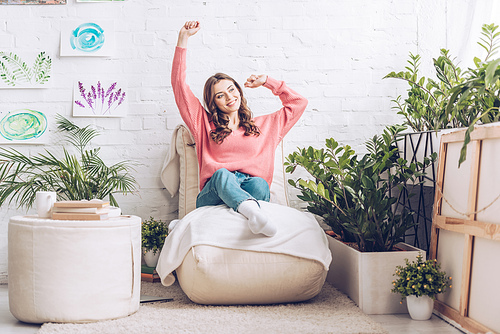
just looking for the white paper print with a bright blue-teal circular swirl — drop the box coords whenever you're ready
[60,20,115,57]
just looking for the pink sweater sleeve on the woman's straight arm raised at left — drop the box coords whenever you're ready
[171,46,205,141]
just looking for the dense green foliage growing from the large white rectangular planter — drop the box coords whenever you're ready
[285,126,435,252]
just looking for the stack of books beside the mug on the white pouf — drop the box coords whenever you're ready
[52,199,109,220]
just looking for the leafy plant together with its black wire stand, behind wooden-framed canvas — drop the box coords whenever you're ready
[384,24,500,250]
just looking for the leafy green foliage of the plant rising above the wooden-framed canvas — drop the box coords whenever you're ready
[384,24,500,165]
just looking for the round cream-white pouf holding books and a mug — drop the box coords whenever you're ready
[8,216,141,323]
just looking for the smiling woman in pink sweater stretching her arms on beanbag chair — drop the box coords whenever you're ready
[175,21,307,236]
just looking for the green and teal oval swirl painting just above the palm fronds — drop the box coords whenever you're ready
[0,109,47,144]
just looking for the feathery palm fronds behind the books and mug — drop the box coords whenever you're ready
[0,115,137,208]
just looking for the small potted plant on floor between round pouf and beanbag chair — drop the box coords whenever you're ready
[142,217,168,267]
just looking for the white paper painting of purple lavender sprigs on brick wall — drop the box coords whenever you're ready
[73,80,128,117]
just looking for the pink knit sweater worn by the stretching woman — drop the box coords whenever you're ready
[171,47,307,189]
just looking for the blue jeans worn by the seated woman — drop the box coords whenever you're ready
[196,168,270,211]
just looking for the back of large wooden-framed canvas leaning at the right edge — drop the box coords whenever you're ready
[429,126,500,333]
